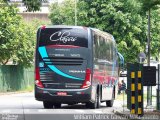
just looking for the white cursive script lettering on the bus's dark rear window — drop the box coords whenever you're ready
[50,31,77,43]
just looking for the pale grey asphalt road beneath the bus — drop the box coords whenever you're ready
[0,93,125,120]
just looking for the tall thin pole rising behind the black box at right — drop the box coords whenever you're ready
[147,9,152,106]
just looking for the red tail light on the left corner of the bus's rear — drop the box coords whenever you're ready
[35,67,44,88]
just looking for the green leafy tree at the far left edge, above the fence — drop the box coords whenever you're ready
[0,5,21,64]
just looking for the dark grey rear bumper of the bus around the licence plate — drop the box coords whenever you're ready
[35,87,91,104]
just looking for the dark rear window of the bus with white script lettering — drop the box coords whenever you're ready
[38,28,88,48]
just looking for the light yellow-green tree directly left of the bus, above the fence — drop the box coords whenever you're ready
[12,19,48,67]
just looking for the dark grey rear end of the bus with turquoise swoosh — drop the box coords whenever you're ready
[35,26,92,105]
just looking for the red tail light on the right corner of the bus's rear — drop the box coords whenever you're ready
[81,68,91,88]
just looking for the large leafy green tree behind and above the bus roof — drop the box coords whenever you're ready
[50,0,145,62]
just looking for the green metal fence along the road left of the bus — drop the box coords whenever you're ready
[0,65,34,92]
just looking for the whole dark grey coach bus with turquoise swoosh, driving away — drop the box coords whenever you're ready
[35,25,118,109]
